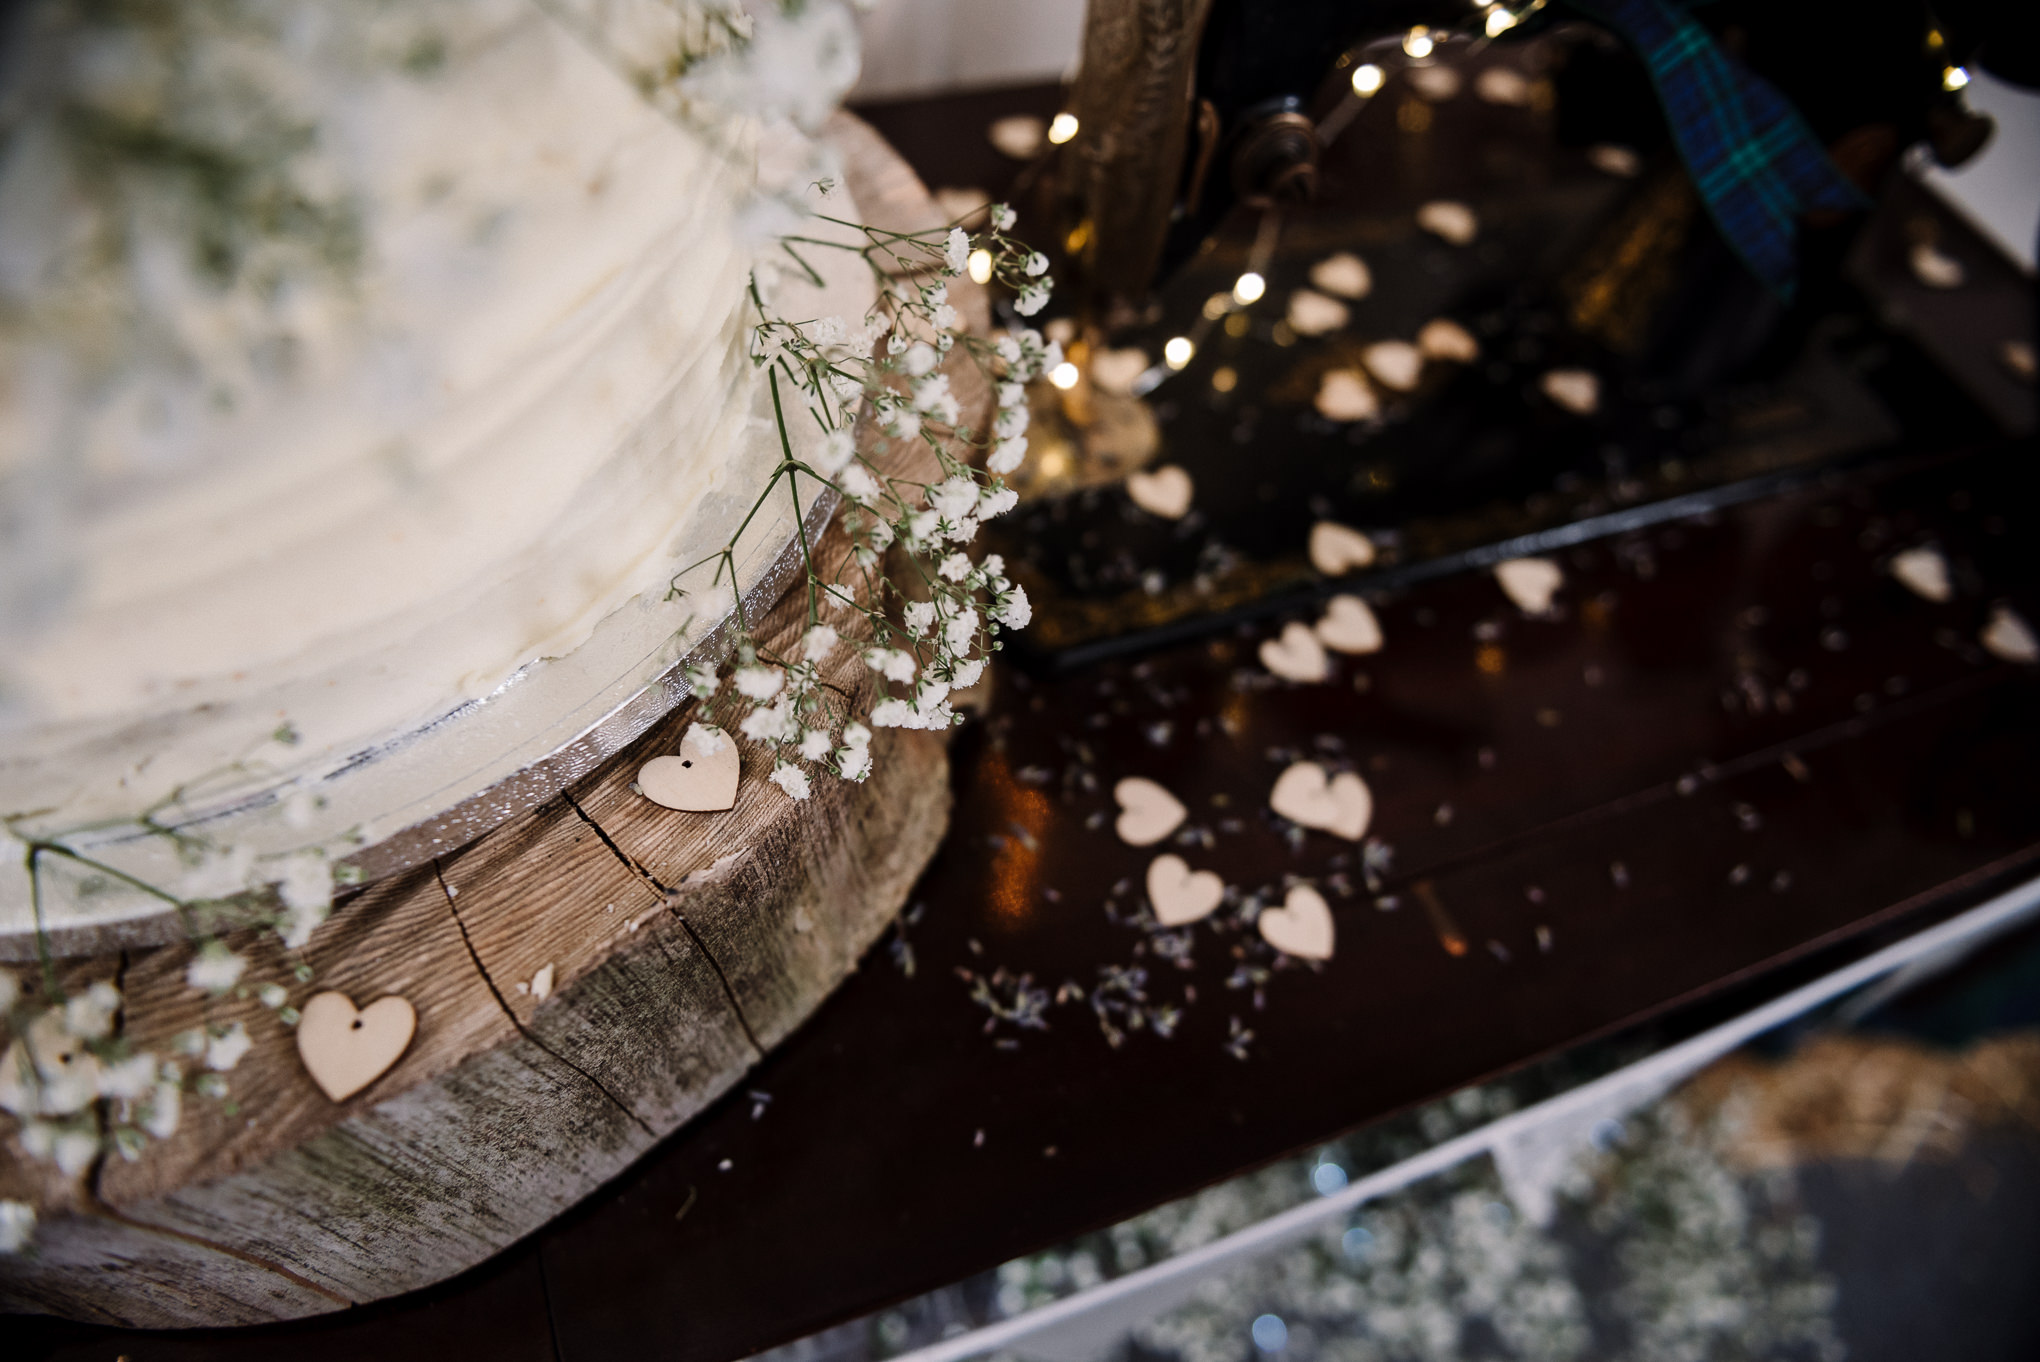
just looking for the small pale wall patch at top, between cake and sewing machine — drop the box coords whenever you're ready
[851,0,1083,100]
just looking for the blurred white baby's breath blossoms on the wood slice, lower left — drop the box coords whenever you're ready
[0,962,253,1252]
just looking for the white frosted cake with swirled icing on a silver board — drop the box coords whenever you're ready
[0,0,869,926]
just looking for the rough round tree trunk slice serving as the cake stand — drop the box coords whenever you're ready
[0,116,962,1327]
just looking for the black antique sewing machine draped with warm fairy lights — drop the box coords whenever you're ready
[991,0,2032,665]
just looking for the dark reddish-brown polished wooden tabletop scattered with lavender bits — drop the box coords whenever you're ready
[19,82,2040,1362]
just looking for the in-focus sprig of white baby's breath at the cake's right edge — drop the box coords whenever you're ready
[675,204,1063,799]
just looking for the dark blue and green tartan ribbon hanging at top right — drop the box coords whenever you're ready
[1573,0,1865,298]
